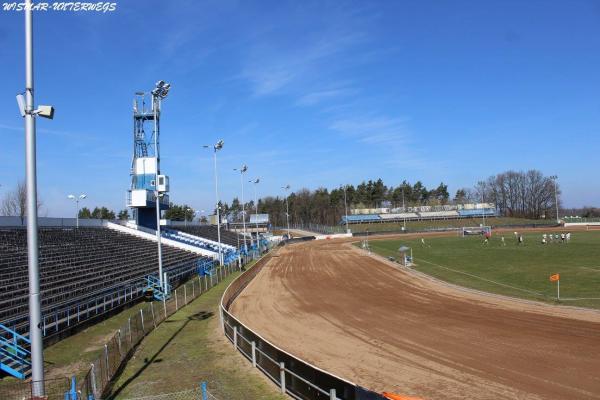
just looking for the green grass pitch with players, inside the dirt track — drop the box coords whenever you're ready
[364,232,600,308]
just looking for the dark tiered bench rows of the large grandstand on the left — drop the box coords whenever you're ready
[0,227,206,337]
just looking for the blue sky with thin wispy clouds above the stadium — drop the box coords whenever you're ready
[0,0,600,216]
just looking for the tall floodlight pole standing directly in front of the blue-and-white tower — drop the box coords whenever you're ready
[151,81,171,293]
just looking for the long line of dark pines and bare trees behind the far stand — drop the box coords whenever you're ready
[220,170,560,226]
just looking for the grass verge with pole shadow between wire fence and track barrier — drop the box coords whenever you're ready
[109,273,286,400]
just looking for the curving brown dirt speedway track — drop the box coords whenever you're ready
[231,241,600,400]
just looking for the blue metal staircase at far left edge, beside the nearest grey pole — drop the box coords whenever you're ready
[0,324,31,379]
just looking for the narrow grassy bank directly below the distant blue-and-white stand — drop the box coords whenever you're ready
[350,217,556,232]
